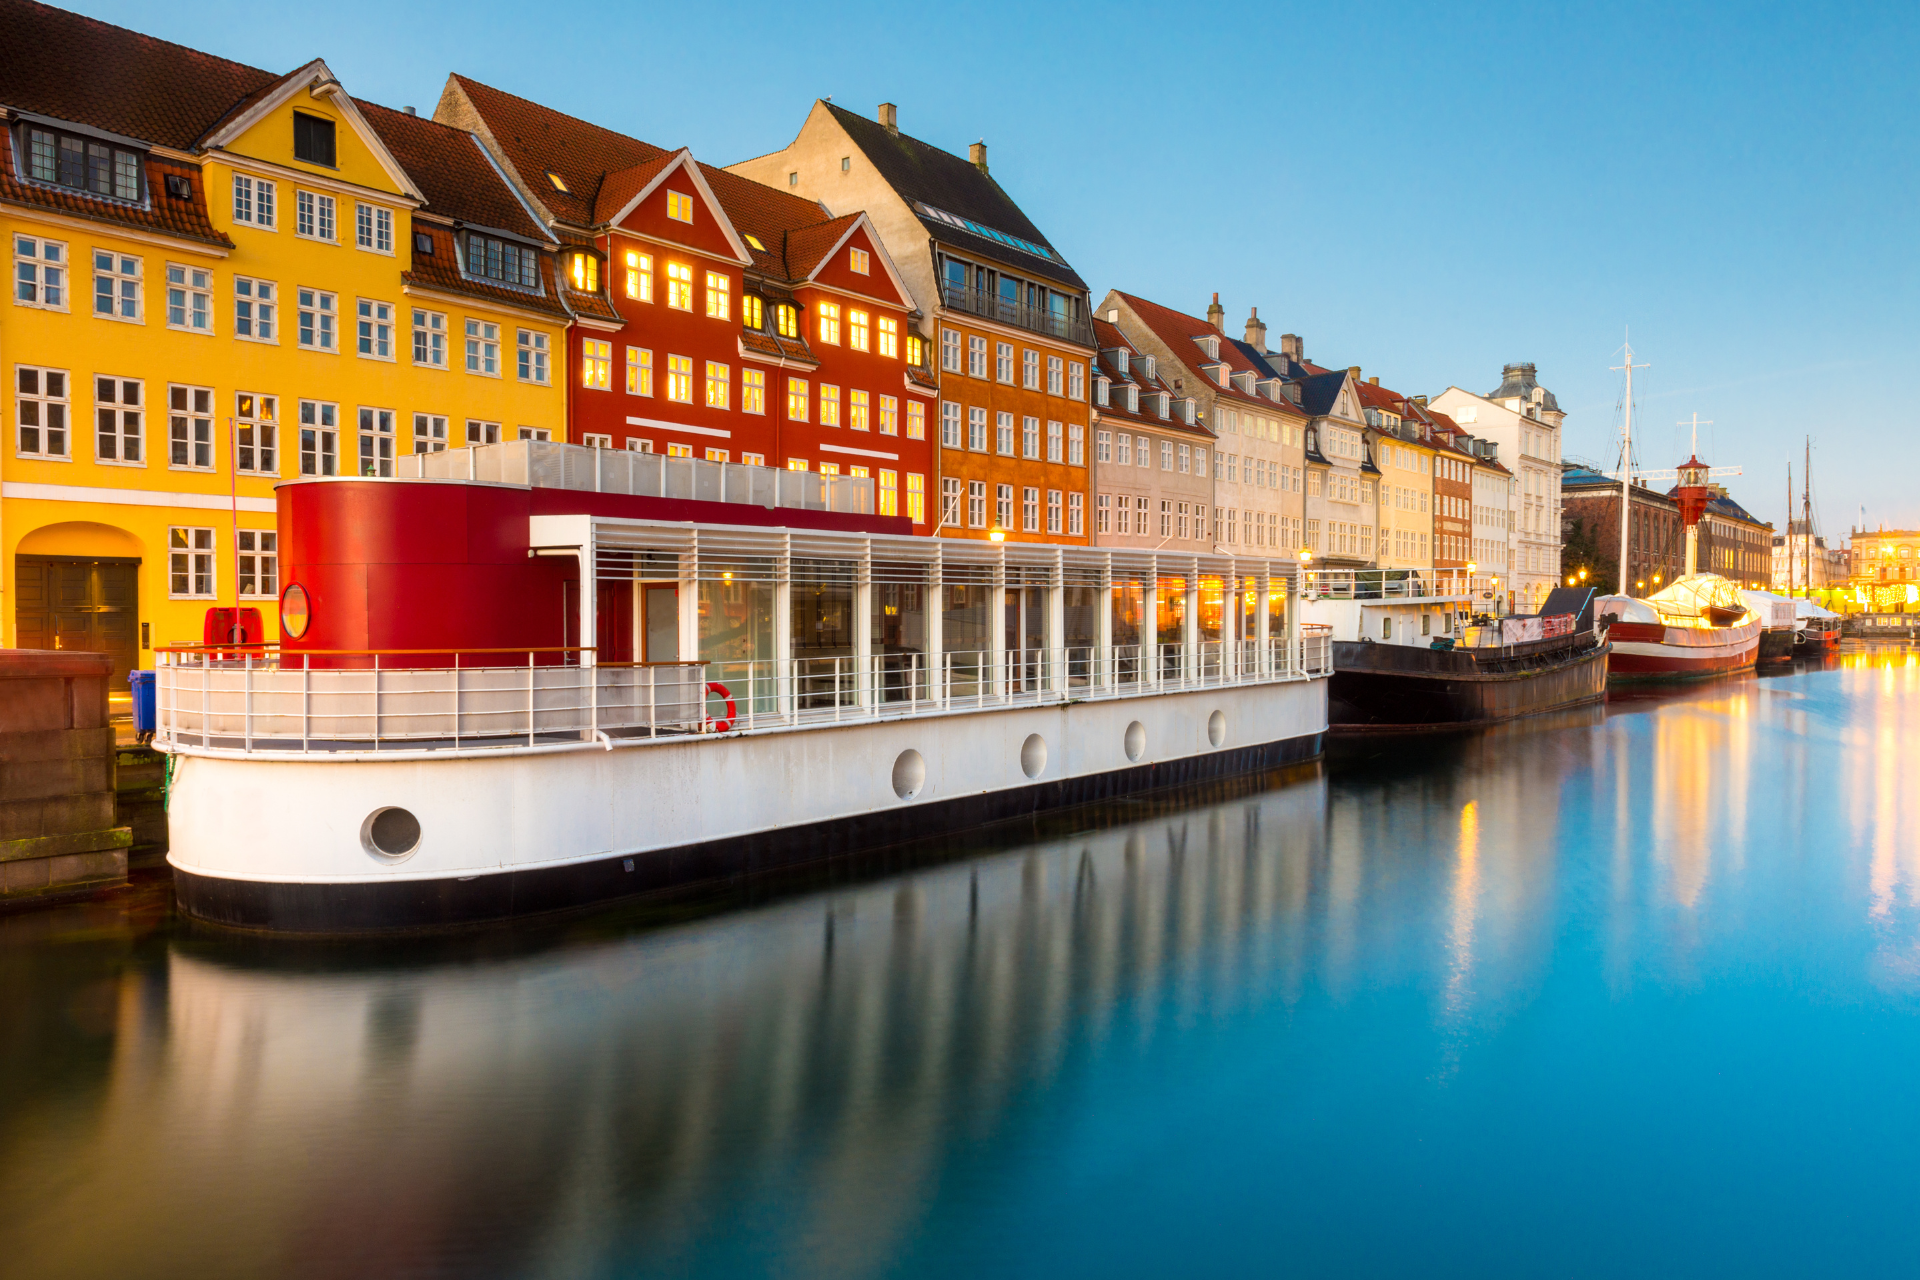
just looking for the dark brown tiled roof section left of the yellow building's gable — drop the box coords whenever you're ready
[0,0,286,152]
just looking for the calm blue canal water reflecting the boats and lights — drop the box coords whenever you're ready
[0,647,1920,1278]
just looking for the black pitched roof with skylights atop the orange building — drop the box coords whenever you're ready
[826,102,1087,290]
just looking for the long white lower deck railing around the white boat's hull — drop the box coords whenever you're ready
[156,637,1332,752]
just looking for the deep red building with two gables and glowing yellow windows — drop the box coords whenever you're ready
[436,75,939,532]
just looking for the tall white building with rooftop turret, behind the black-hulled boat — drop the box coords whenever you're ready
[1432,365,1567,612]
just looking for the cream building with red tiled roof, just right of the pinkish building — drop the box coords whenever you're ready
[1100,290,1308,557]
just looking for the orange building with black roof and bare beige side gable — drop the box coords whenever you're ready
[730,100,1094,545]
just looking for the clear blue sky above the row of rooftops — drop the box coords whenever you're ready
[75,0,1920,533]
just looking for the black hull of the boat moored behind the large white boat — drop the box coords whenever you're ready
[1327,641,1609,733]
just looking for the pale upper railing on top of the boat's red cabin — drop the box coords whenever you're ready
[394,439,874,516]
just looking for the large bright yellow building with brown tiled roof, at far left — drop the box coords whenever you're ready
[0,0,568,687]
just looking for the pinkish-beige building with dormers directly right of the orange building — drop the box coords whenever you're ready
[1092,319,1215,553]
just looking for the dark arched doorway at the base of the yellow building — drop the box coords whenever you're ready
[13,520,142,691]
